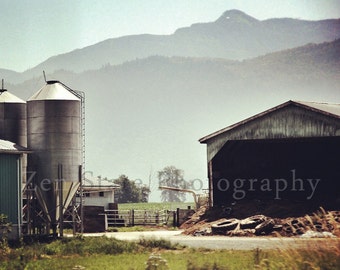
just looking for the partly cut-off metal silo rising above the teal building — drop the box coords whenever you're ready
[0,86,27,146]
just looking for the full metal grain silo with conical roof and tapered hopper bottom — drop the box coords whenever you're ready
[27,81,82,230]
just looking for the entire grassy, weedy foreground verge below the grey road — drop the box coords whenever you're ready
[0,236,340,270]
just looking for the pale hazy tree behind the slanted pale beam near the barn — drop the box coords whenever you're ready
[158,166,188,202]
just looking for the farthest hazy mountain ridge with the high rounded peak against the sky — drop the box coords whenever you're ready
[3,10,340,83]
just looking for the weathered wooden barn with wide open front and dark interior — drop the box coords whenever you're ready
[199,101,340,217]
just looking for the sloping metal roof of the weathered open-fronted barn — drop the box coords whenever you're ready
[199,100,340,143]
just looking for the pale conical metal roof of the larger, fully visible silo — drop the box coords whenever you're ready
[28,81,80,101]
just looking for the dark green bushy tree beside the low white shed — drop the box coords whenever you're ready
[113,175,150,203]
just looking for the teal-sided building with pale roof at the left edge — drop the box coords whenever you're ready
[0,140,27,239]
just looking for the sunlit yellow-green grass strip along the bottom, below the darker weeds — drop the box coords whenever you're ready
[5,249,340,270]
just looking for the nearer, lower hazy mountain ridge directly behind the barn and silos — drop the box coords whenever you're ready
[6,12,340,180]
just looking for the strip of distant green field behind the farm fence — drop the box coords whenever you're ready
[118,202,195,210]
